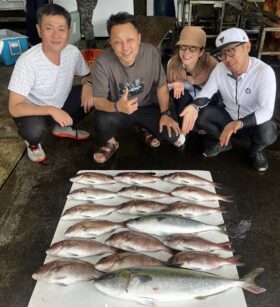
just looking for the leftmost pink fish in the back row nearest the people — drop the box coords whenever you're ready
[70,172,116,185]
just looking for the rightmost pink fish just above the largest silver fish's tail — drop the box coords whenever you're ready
[168,251,244,271]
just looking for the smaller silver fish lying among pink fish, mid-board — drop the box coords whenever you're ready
[126,214,225,235]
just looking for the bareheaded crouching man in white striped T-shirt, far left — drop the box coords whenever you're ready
[8,4,93,162]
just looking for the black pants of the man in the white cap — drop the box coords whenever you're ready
[197,106,277,152]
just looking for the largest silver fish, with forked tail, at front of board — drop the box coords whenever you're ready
[94,267,266,305]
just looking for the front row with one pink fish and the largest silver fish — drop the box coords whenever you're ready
[33,256,266,305]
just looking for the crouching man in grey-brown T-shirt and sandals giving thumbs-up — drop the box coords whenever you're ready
[92,12,184,163]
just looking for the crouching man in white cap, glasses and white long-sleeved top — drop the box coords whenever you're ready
[181,28,277,171]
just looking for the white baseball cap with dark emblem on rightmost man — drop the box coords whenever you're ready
[214,28,249,53]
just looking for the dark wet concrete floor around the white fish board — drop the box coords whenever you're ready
[0,41,280,307]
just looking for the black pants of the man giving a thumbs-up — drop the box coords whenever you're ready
[95,105,178,143]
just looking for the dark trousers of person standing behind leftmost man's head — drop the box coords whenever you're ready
[26,0,48,46]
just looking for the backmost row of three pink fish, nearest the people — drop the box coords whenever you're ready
[70,172,220,187]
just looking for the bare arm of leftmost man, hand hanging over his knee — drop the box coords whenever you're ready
[9,91,73,127]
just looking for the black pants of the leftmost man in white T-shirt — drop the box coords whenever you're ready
[14,85,87,145]
